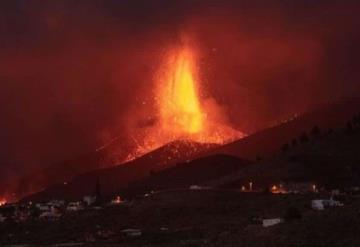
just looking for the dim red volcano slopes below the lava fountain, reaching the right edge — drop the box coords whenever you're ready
[21,97,360,200]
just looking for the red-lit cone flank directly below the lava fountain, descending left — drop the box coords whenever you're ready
[25,141,219,200]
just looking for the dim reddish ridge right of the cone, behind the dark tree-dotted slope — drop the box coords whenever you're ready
[206,99,360,160]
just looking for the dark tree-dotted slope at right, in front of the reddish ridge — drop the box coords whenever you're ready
[208,116,360,188]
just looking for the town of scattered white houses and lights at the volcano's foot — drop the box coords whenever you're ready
[0,179,360,246]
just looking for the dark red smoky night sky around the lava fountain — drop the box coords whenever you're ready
[0,0,360,194]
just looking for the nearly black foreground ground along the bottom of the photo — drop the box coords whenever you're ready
[0,190,360,247]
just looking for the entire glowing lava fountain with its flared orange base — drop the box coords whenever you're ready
[128,46,244,159]
